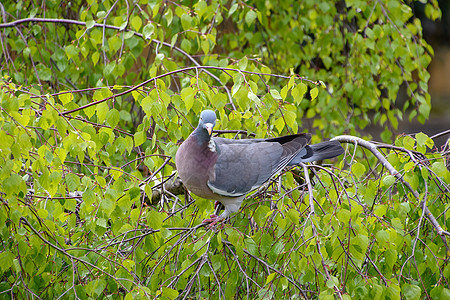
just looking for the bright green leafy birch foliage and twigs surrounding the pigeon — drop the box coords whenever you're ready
[0,0,450,299]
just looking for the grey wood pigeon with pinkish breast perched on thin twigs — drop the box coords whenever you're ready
[175,110,344,226]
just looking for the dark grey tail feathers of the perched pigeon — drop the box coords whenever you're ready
[289,141,344,166]
